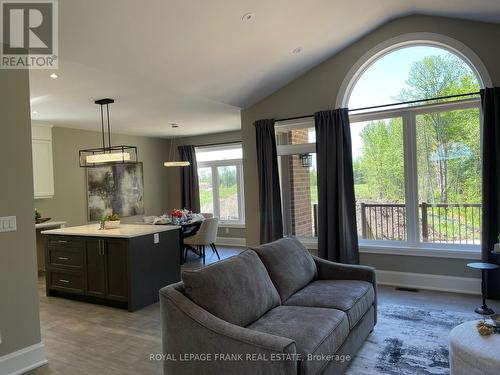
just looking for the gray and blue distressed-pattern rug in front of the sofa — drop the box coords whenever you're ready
[347,304,478,375]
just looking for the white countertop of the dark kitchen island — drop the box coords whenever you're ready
[41,224,180,238]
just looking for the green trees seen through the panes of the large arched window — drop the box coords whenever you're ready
[353,53,481,203]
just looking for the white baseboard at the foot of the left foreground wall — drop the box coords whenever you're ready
[0,342,47,375]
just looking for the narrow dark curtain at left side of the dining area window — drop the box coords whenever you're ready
[179,146,200,212]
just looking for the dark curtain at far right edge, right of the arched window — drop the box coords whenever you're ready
[481,87,500,299]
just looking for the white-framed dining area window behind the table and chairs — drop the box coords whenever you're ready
[196,143,245,225]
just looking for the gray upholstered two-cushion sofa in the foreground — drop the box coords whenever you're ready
[160,238,377,375]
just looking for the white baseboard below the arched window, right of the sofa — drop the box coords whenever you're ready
[376,270,481,295]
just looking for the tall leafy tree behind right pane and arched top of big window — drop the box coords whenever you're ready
[398,53,479,203]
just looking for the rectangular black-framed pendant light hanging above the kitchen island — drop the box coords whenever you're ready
[79,99,137,168]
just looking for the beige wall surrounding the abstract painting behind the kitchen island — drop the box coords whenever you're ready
[35,128,174,226]
